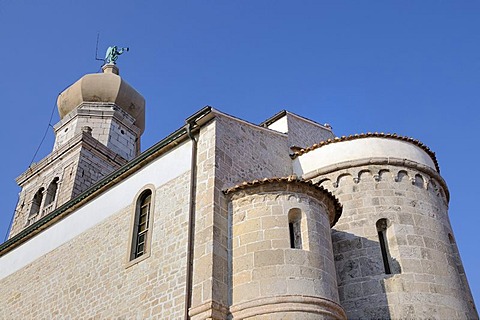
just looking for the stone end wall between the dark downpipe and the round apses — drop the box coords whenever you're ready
[191,115,292,319]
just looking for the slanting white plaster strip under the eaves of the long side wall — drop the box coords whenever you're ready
[0,141,191,279]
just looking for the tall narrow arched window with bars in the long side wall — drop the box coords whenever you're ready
[130,190,152,260]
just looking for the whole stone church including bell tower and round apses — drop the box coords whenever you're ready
[0,63,478,320]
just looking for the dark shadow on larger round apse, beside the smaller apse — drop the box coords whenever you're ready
[332,230,400,319]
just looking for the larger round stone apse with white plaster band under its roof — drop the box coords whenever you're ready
[294,133,478,319]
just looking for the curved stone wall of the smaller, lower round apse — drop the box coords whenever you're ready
[230,182,344,319]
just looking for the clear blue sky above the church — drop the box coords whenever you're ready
[0,0,480,306]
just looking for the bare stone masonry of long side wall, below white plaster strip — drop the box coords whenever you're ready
[0,172,190,319]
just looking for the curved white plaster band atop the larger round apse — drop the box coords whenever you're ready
[293,137,436,176]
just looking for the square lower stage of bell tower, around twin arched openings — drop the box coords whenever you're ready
[9,133,125,238]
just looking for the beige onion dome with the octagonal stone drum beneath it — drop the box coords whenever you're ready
[55,63,145,160]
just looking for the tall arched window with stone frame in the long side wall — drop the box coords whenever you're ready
[129,189,153,261]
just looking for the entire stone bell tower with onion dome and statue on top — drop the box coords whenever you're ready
[9,58,145,237]
